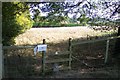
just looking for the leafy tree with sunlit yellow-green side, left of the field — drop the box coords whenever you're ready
[2,2,32,45]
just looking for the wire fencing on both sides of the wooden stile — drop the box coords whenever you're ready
[3,36,120,78]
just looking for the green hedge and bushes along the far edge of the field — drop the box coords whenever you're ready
[33,15,90,27]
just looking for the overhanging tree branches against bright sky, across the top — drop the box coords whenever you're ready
[30,0,120,24]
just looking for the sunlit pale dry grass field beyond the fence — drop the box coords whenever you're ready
[15,27,103,45]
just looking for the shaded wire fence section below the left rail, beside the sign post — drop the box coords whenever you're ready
[4,48,41,78]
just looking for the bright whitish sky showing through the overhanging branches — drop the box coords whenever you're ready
[30,0,120,20]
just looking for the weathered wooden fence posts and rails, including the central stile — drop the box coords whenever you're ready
[3,36,120,75]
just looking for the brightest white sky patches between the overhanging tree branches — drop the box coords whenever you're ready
[30,0,118,19]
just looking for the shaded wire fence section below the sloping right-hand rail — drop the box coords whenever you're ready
[72,37,120,69]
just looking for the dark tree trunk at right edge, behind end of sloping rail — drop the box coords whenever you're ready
[113,26,120,57]
